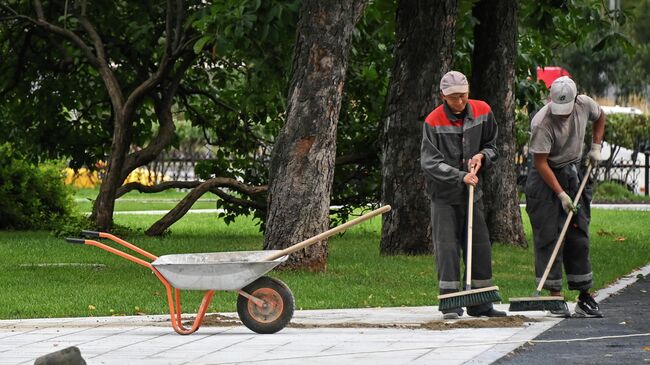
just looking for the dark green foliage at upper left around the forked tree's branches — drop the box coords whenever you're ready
[0,1,170,167]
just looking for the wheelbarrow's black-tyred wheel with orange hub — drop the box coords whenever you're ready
[237,276,295,334]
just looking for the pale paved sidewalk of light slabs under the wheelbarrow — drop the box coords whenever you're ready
[0,266,650,365]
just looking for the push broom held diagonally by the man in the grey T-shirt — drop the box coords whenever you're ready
[508,163,592,312]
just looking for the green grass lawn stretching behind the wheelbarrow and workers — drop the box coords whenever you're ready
[0,196,650,319]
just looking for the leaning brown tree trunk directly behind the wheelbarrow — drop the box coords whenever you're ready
[264,0,366,271]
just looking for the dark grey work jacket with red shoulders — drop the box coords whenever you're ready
[420,99,498,205]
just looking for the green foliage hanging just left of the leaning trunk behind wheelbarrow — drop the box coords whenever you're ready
[181,0,299,228]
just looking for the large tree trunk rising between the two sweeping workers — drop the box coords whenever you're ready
[470,0,526,245]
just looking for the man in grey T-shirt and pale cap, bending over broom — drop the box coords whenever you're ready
[524,76,605,317]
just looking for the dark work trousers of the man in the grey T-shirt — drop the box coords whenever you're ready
[525,163,593,291]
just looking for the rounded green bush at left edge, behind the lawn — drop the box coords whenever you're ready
[0,144,72,229]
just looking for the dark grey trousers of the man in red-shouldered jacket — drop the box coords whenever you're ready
[431,196,492,314]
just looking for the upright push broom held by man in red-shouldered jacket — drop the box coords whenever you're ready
[438,170,501,311]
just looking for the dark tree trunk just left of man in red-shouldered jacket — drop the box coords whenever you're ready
[381,0,458,255]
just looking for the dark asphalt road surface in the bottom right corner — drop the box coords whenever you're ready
[495,276,650,365]
